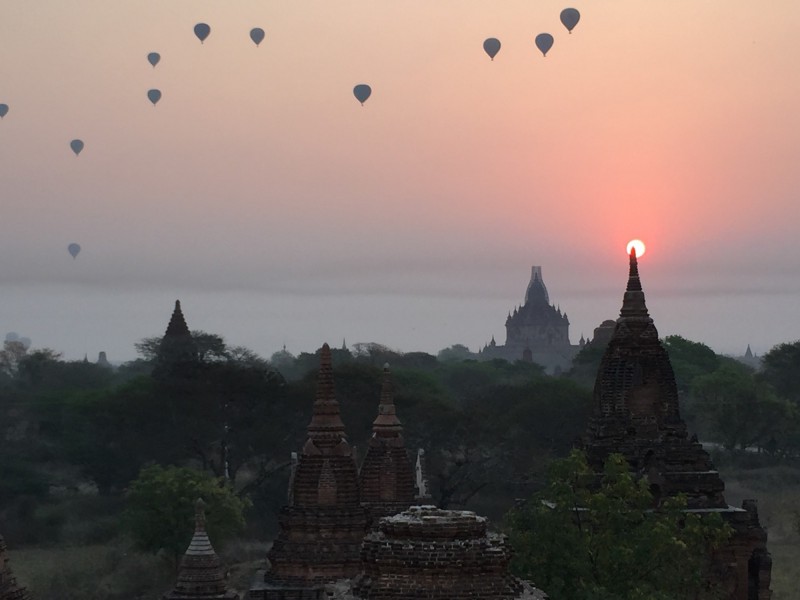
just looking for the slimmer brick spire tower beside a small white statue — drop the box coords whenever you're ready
[359,364,415,523]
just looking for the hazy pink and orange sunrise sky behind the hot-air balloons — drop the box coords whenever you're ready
[0,0,800,361]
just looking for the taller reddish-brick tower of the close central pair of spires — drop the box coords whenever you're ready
[249,344,366,600]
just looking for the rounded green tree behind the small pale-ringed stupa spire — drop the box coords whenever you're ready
[123,465,249,565]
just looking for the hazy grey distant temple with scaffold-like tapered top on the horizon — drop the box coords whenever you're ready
[479,266,580,374]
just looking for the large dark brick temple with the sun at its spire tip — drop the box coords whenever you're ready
[582,246,772,600]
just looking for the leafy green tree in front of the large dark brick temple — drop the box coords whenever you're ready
[506,451,730,600]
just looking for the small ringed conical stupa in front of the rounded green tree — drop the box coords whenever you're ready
[162,498,239,600]
